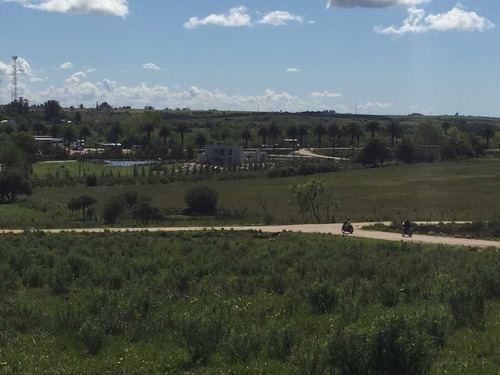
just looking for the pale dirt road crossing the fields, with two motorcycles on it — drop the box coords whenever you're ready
[0,223,500,249]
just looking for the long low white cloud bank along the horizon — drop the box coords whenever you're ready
[23,77,345,112]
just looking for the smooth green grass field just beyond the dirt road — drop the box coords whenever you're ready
[6,159,500,227]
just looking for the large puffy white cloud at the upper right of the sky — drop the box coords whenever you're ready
[374,6,495,35]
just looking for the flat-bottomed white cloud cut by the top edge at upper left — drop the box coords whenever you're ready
[4,0,129,17]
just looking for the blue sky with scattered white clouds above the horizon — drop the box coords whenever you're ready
[0,0,500,116]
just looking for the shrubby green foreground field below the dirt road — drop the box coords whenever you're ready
[0,232,500,375]
